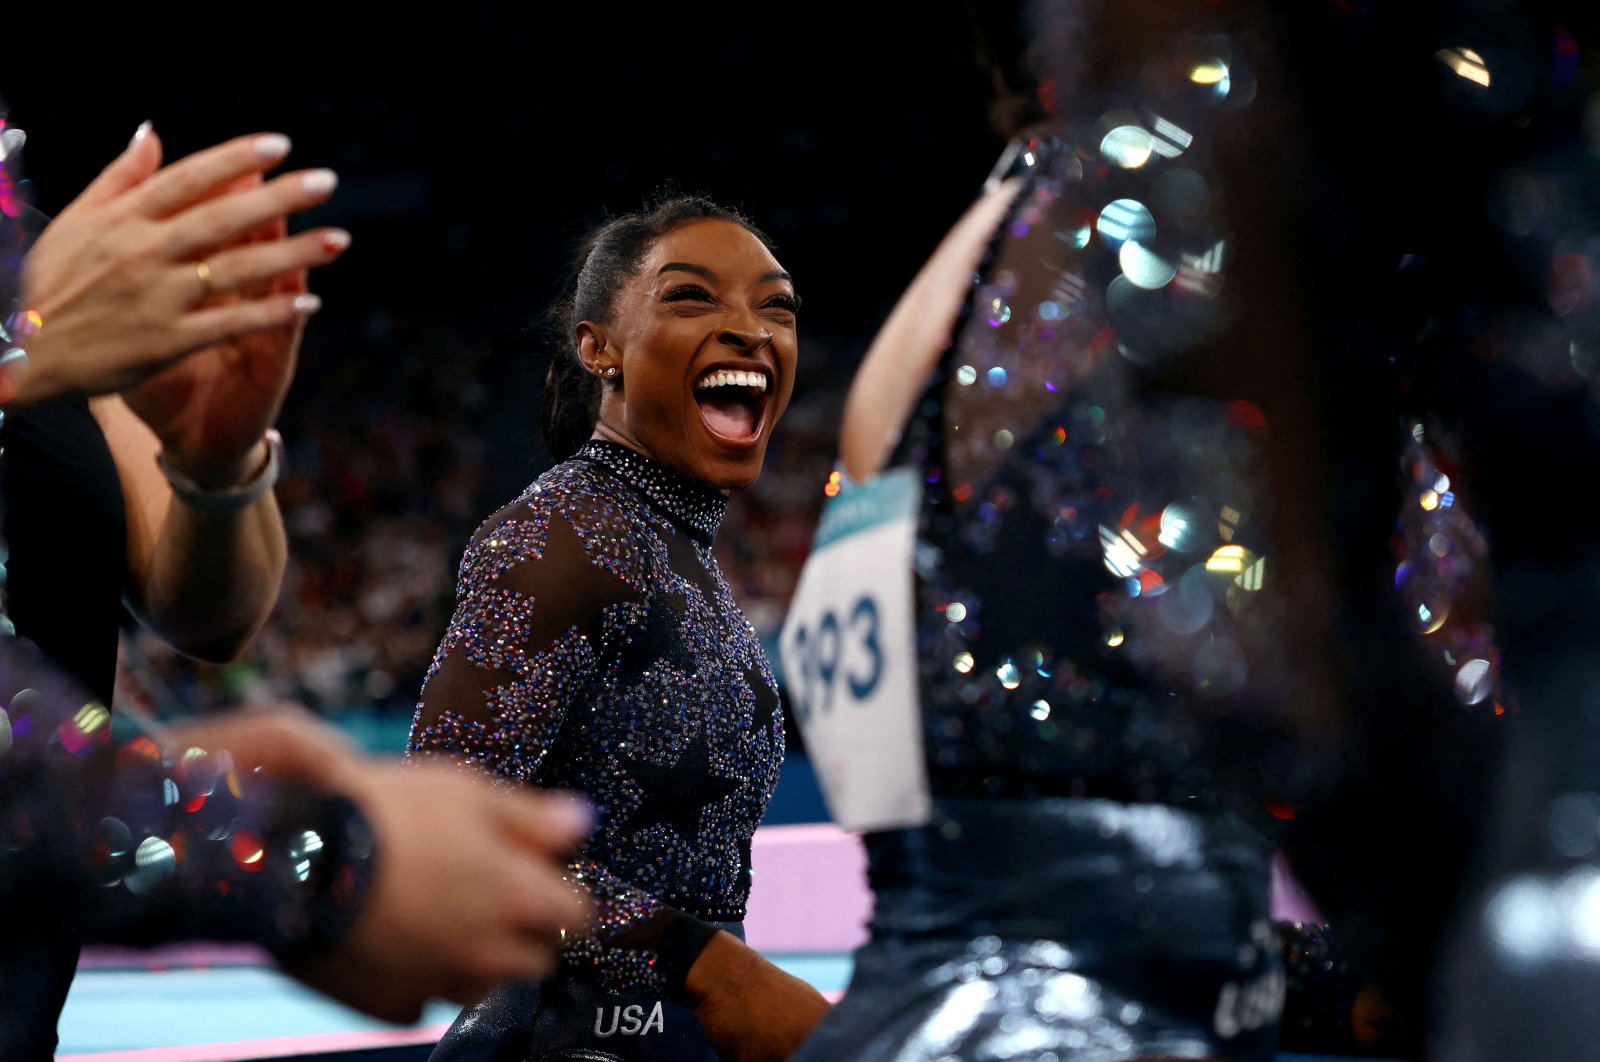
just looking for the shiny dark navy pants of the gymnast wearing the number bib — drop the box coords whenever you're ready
[794,798,1283,1062]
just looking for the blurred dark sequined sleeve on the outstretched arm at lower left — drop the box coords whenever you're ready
[0,637,373,964]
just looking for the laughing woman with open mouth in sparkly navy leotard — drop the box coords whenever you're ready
[408,198,827,1062]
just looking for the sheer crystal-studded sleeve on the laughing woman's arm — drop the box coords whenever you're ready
[406,494,715,996]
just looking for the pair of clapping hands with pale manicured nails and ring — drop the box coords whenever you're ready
[14,126,349,407]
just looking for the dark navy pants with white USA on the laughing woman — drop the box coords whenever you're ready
[429,921,744,1062]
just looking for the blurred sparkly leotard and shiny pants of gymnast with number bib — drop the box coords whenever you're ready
[797,35,1312,1062]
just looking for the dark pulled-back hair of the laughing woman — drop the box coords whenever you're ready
[541,195,774,461]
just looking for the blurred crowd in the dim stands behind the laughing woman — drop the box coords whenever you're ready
[118,299,850,752]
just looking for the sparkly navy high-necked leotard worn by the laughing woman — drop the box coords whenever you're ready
[408,441,784,995]
